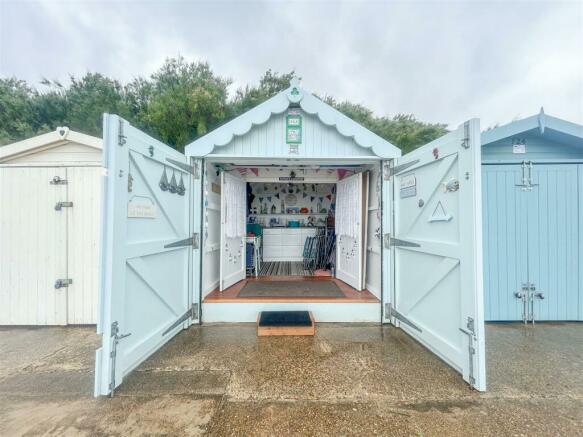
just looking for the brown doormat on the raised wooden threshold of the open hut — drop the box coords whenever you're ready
[238,281,344,297]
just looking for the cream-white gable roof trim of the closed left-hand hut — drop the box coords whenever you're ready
[0,127,103,161]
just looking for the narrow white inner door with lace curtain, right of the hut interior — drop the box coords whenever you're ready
[336,173,366,290]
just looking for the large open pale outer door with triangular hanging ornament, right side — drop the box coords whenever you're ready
[384,120,486,390]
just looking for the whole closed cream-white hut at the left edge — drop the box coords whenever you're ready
[0,127,103,325]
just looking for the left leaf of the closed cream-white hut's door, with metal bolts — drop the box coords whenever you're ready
[0,167,70,325]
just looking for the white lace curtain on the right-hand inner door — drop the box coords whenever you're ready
[336,177,360,239]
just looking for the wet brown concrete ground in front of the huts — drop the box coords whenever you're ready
[0,324,583,436]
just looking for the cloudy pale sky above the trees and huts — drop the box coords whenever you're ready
[0,0,583,129]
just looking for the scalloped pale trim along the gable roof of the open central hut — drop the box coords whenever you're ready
[185,78,401,158]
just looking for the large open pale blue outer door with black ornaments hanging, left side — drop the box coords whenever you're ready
[95,114,201,396]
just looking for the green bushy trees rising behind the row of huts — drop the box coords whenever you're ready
[0,57,447,152]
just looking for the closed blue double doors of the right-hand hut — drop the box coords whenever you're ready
[482,163,583,321]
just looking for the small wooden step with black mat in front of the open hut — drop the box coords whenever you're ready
[257,311,316,336]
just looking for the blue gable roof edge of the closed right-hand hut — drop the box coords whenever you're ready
[482,108,583,146]
